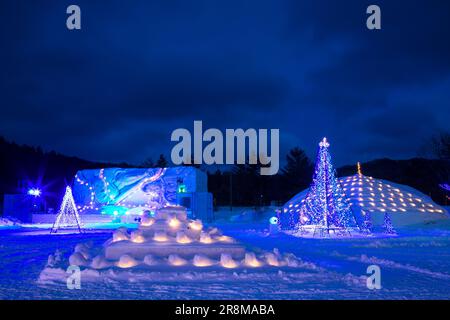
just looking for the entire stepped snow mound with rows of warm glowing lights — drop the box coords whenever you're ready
[40,206,305,281]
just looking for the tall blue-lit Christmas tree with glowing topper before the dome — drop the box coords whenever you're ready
[297,138,358,236]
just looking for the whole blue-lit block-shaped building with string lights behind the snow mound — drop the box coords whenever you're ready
[73,167,212,221]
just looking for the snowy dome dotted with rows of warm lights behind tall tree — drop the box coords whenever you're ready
[281,174,447,226]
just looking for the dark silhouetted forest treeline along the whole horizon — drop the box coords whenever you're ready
[0,137,450,212]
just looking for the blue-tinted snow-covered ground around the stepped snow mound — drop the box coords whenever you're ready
[0,209,450,299]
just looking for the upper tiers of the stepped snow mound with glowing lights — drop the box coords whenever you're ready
[104,207,245,267]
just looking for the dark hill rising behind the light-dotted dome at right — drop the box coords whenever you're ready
[337,158,450,205]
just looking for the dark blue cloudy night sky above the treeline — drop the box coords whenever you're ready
[0,0,450,164]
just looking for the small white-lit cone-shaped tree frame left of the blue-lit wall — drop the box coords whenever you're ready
[50,186,81,233]
